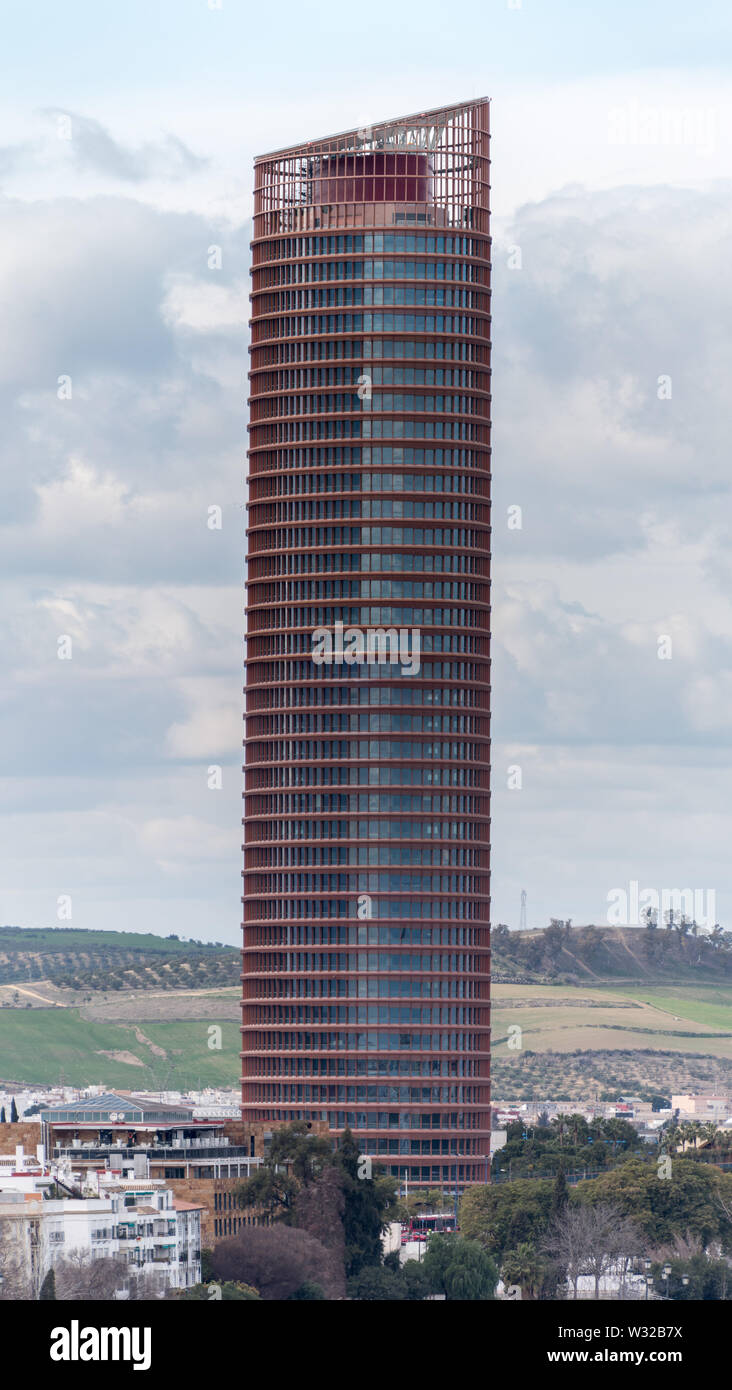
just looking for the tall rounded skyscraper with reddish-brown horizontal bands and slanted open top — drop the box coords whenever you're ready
[242,100,490,1184]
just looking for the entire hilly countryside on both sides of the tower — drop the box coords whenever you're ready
[0,923,732,1101]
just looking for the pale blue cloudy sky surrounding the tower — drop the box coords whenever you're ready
[0,0,732,942]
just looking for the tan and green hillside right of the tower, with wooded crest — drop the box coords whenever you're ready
[490,919,732,1101]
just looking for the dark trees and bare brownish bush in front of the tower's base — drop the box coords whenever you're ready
[178,1123,499,1302]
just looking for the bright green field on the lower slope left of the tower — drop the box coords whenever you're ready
[0,1008,240,1090]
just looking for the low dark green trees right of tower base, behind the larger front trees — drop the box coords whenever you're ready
[492,1115,647,1177]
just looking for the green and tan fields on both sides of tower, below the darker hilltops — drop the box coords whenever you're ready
[0,973,732,1097]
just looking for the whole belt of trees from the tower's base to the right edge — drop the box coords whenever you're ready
[186,1139,732,1302]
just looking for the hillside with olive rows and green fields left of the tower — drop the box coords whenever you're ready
[0,927,242,1090]
